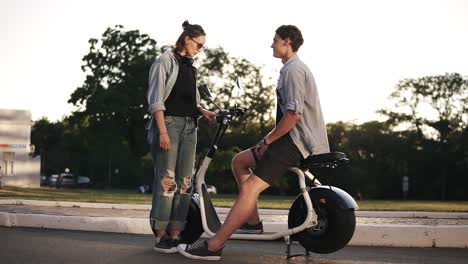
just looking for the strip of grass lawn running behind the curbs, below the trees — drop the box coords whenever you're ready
[0,187,468,212]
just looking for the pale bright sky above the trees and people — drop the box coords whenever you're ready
[0,0,468,123]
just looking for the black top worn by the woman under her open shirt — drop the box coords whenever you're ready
[164,52,198,117]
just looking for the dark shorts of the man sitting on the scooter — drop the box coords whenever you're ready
[250,134,302,185]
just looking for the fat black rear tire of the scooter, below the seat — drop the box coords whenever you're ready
[288,193,356,254]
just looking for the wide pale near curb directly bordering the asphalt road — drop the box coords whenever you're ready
[0,212,468,248]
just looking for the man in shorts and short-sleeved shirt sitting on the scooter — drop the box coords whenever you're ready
[177,25,330,260]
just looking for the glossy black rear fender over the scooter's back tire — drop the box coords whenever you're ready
[308,185,359,210]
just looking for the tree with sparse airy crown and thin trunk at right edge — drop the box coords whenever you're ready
[379,73,468,199]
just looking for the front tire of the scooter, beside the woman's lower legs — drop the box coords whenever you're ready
[180,194,203,244]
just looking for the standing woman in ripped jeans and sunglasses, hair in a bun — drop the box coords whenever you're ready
[148,21,216,253]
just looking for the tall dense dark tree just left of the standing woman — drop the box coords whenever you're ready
[68,26,158,184]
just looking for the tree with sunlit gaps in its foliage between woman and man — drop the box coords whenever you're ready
[192,47,275,192]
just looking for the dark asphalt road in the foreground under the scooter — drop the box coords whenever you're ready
[0,227,468,264]
